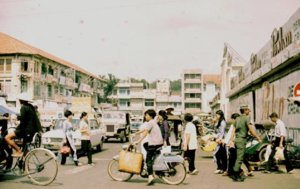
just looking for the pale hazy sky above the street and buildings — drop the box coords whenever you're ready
[0,0,300,81]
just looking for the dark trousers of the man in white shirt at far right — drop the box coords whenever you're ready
[266,137,293,172]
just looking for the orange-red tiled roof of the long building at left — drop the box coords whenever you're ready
[0,32,103,80]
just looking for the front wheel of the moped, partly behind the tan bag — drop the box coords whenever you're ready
[107,159,133,182]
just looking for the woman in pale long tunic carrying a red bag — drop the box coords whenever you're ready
[61,110,79,166]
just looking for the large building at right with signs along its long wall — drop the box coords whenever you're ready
[226,9,300,130]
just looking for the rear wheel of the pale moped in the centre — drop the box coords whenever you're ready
[161,163,186,185]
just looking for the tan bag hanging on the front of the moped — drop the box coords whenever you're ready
[119,148,143,174]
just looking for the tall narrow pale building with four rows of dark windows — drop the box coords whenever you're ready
[181,69,203,114]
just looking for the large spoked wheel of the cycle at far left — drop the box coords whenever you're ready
[25,148,58,185]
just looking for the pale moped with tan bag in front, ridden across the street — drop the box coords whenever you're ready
[108,142,186,185]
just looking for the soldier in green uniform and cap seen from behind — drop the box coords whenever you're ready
[231,105,261,182]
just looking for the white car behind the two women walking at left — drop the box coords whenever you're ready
[42,118,105,151]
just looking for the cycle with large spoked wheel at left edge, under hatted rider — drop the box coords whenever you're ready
[0,133,58,186]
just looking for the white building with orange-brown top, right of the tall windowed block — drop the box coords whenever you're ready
[202,74,221,113]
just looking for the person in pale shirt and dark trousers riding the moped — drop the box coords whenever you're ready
[135,109,163,185]
